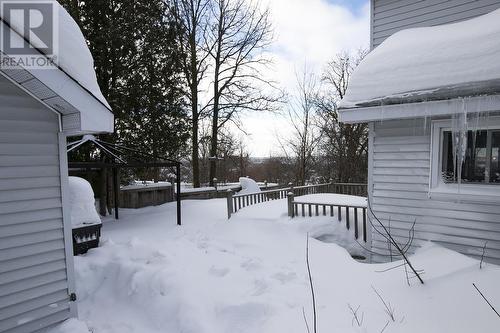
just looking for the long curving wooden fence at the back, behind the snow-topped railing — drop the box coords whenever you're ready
[226,183,367,219]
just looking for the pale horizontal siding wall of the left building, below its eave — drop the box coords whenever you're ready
[0,79,72,333]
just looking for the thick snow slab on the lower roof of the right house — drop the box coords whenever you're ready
[339,9,500,109]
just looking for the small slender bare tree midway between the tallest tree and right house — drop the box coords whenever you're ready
[278,66,321,185]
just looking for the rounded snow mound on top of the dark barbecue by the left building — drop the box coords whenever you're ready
[68,177,101,226]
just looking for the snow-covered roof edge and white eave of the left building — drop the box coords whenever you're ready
[0,1,114,135]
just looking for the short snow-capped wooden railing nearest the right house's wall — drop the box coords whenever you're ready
[287,193,367,243]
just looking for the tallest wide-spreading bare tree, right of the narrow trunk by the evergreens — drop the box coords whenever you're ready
[205,0,278,185]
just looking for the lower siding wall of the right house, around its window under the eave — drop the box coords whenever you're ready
[370,119,500,263]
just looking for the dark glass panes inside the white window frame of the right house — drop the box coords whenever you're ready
[441,129,500,184]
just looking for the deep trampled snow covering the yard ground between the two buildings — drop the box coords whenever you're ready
[52,199,500,333]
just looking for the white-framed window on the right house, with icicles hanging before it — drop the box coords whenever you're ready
[429,116,500,203]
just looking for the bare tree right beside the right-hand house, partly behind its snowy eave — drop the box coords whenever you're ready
[317,50,368,182]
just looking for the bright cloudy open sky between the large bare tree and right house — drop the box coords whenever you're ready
[238,0,370,157]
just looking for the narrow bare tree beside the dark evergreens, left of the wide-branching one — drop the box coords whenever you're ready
[174,0,210,187]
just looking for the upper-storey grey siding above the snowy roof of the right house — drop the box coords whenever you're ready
[370,0,500,48]
